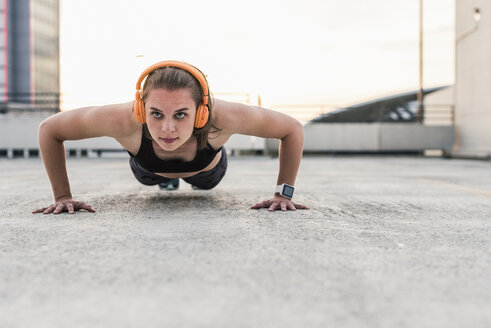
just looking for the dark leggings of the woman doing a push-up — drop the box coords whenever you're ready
[130,147,231,189]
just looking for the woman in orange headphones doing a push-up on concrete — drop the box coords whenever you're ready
[33,61,308,214]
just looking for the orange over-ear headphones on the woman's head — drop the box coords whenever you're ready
[133,60,210,129]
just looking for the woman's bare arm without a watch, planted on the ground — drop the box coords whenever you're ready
[33,103,138,214]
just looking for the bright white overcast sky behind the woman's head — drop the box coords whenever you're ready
[61,0,455,109]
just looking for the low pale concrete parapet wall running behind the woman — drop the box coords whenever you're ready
[0,113,455,157]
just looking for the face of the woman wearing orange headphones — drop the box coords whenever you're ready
[145,89,196,151]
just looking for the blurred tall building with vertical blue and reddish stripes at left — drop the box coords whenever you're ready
[0,0,60,112]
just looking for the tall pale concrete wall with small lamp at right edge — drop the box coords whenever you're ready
[454,0,491,157]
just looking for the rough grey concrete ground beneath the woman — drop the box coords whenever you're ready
[0,157,491,328]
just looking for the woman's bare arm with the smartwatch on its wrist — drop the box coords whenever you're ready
[215,99,308,211]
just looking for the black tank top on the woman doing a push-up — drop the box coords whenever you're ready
[128,129,222,173]
